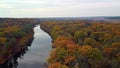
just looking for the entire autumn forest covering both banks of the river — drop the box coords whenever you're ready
[0,18,120,68]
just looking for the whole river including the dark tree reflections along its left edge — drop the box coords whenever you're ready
[0,26,51,68]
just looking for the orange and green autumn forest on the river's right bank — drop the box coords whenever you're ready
[41,20,120,68]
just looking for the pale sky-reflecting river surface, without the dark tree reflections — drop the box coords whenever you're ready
[17,26,52,68]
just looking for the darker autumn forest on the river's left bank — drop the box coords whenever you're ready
[0,18,38,64]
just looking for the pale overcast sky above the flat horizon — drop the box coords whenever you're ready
[0,0,120,18]
